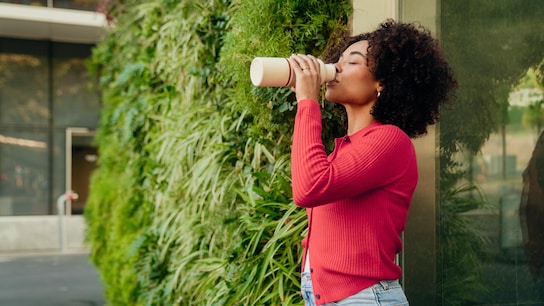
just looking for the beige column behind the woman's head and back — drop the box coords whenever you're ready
[351,0,439,305]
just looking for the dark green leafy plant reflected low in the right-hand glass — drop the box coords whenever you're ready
[437,164,489,305]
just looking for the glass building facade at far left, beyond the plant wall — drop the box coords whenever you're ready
[0,38,100,216]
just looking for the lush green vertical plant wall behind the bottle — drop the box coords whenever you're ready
[85,0,351,305]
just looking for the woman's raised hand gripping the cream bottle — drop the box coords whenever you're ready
[287,54,321,102]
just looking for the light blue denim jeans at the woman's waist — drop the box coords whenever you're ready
[301,272,408,306]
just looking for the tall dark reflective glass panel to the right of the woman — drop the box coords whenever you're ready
[438,0,544,305]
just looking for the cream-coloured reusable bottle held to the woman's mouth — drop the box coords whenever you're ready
[249,57,336,87]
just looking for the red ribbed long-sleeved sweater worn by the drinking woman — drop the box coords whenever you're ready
[291,100,418,305]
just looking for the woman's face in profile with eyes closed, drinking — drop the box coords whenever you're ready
[325,40,382,105]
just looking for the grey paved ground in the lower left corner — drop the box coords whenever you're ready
[0,253,106,306]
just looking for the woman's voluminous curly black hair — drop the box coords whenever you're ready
[325,19,457,138]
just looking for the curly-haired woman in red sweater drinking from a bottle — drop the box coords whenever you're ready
[289,20,457,305]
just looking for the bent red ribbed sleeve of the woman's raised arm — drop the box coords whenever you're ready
[291,100,413,207]
